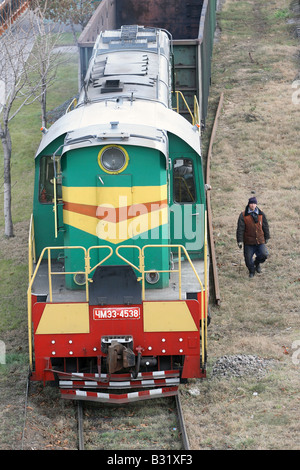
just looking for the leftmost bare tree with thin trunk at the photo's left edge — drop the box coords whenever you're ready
[0,11,40,237]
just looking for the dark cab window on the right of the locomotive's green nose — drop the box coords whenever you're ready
[173,158,196,203]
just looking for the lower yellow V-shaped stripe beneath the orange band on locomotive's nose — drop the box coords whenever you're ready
[63,207,168,244]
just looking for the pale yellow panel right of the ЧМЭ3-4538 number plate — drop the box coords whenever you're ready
[143,301,198,333]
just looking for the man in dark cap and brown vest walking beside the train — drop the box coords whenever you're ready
[236,197,270,278]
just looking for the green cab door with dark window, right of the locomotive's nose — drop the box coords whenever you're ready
[170,153,204,254]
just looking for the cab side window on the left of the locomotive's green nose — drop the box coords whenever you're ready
[39,156,62,204]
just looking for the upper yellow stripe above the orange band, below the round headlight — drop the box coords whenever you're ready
[62,185,167,207]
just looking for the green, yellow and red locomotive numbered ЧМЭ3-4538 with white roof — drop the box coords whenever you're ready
[28,25,209,403]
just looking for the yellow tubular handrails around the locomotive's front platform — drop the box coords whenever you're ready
[27,216,208,367]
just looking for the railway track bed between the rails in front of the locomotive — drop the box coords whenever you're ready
[77,395,190,450]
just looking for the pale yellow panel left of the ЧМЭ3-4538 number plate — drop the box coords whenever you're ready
[36,303,90,335]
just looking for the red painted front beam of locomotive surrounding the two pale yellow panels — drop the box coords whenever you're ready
[32,300,203,380]
